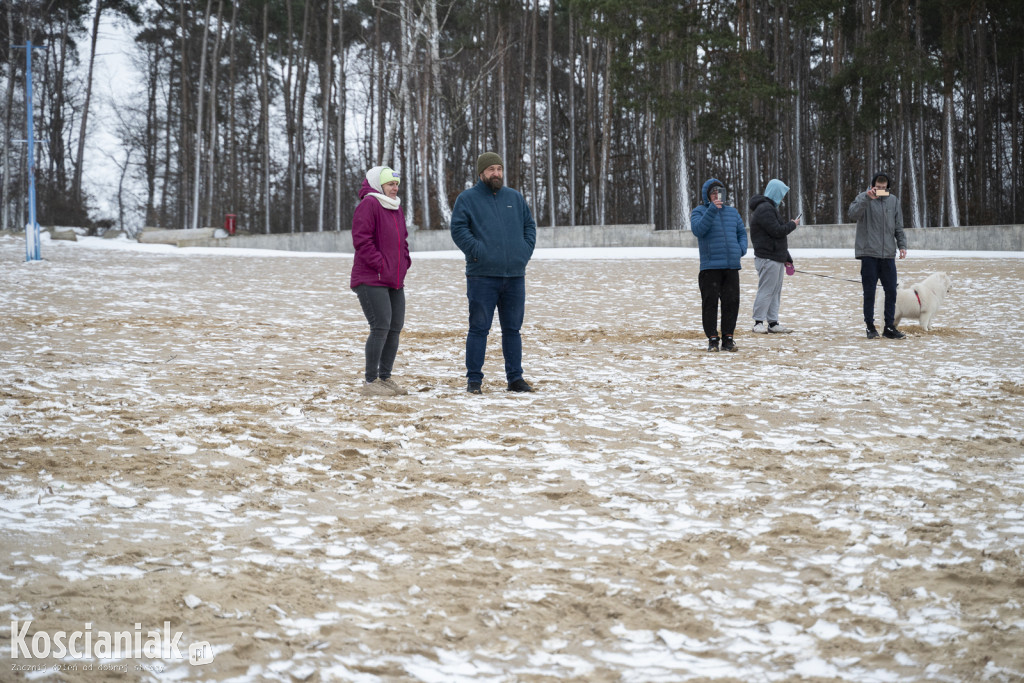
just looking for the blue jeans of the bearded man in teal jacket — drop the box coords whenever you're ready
[466,276,526,383]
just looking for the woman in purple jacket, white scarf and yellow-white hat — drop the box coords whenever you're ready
[349,166,412,396]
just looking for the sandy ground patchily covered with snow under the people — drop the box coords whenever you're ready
[0,238,1024,682]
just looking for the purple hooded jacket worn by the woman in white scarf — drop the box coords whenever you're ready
[349,180,413,290]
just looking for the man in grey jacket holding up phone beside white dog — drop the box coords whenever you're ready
[849,173,906,339]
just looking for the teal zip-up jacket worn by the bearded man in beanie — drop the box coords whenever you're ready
[452,180,537,278]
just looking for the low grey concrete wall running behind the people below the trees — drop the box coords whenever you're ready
[166,223,1024,254]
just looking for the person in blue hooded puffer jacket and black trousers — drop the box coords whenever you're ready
[690,178,746,351]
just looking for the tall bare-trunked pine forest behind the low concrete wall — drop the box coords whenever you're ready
[0,0,1024,232]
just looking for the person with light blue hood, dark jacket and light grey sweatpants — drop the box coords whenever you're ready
[749,178,800,334]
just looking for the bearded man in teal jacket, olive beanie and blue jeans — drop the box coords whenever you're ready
[452,152,537,393]
